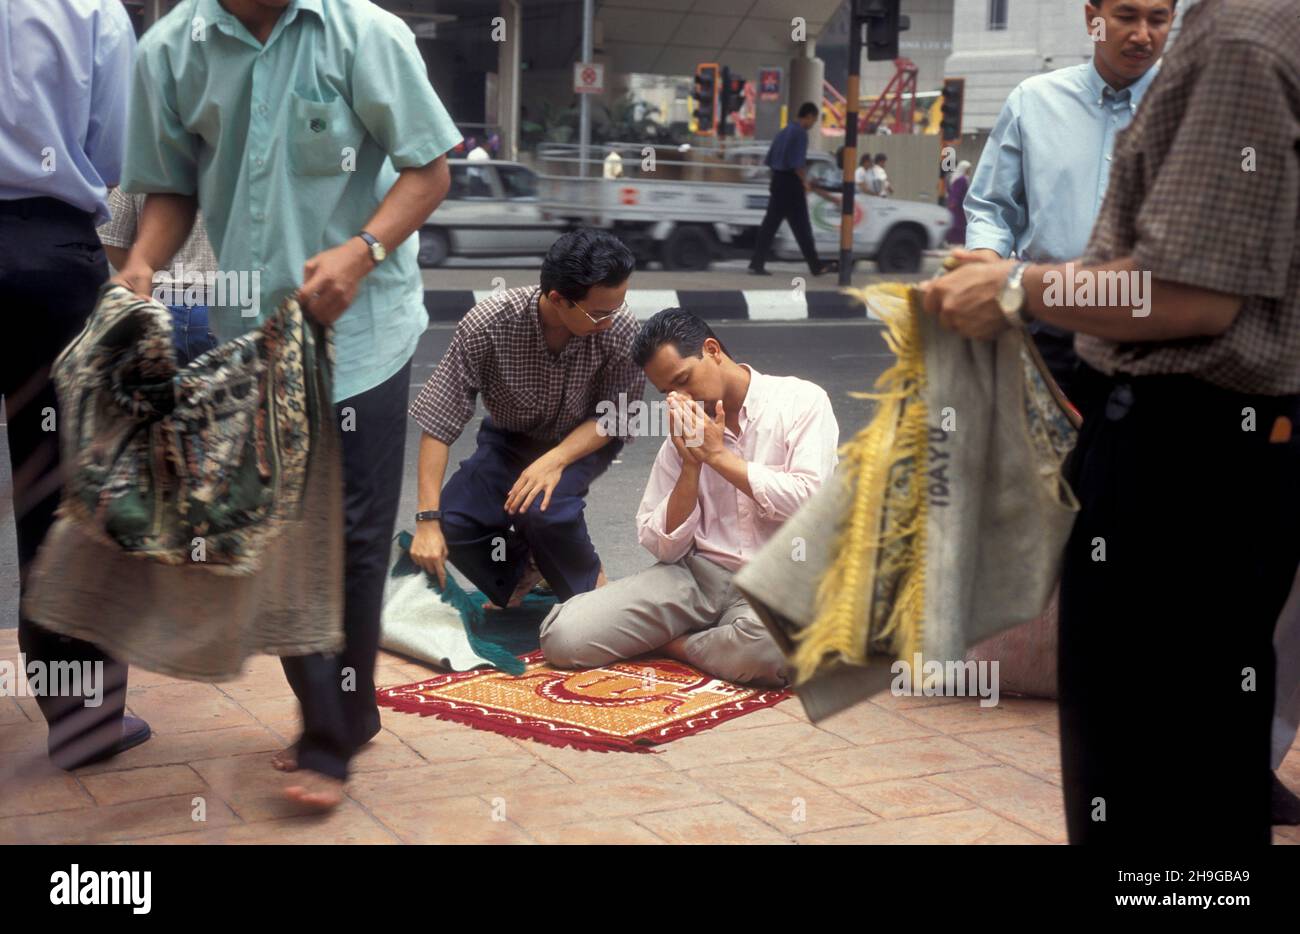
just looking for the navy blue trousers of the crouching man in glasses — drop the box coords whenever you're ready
[441,418,623,606]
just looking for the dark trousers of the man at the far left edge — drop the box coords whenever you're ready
[0,198,126,769]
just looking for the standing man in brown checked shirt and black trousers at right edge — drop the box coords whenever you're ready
[926,0,1300,844]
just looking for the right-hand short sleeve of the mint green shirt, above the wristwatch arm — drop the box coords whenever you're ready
[352,14,460,169]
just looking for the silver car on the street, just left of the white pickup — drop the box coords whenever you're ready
[420,159,564,267]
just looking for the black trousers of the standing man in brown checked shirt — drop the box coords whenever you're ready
[1058,366,1300,847]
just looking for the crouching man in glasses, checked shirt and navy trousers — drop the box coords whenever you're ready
[411,230,645,606]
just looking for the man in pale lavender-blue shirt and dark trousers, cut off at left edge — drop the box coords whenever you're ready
[0,0,150,769]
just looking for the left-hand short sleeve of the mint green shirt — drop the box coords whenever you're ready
[122,35,199,195]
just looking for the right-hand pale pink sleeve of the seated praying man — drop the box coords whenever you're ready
[749,388,840,522]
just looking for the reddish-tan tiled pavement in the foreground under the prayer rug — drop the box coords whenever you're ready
[0,630,1300,843]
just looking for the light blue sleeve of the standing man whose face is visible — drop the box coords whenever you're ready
[965,88,1030,256]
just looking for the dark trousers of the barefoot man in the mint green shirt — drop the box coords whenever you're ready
[281,360,411,779]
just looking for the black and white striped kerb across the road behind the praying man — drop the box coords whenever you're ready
[424,289,875,324]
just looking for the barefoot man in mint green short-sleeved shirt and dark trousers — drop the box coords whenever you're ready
[118,0,460,808]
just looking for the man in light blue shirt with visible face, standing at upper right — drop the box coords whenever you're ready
[966,0,1177,395]
